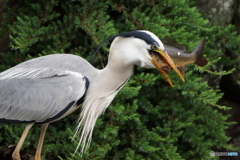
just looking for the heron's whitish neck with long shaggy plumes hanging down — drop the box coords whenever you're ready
[75,52,133,152]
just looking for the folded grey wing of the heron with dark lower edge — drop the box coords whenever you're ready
[0,68,89,123]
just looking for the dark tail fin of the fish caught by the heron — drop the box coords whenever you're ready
[192,39,208,66]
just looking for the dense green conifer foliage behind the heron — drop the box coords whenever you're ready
[0,0,240,160]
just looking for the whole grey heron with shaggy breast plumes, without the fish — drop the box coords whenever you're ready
[0,30,184,160]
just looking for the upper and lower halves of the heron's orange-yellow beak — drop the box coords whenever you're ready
[152,48,185,87]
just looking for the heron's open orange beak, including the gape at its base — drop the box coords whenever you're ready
[150,46,185,87]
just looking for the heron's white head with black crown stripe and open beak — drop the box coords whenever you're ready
[109,30,184,86]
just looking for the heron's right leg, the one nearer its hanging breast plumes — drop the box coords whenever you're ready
[35,123,49,160]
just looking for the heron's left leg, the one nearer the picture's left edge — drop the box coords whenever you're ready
[12,123,34,160]
